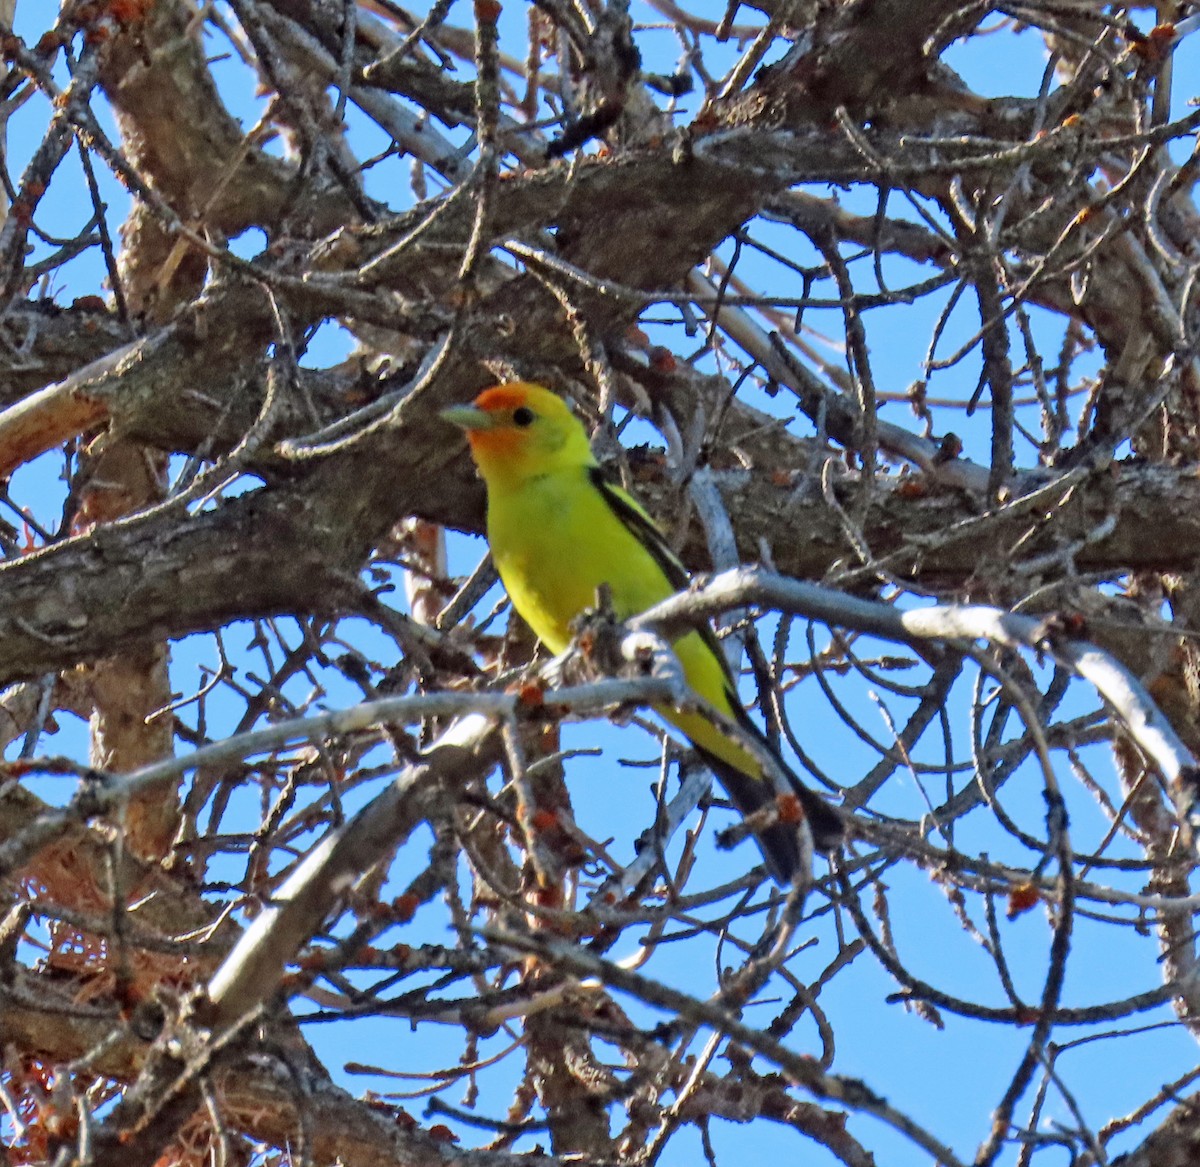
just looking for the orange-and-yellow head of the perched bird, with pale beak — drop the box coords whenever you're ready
[442,381,595,490]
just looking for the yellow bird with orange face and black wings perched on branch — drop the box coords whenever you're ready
[442,381,844,884]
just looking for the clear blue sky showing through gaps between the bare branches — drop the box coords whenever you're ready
[8,0,1200,1167]
